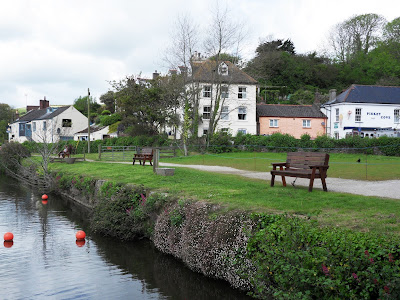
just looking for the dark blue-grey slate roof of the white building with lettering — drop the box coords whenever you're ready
[326,84,400,104]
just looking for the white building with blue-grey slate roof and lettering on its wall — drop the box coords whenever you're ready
[321,84,400,139]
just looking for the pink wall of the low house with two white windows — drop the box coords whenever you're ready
[259,117,326,139]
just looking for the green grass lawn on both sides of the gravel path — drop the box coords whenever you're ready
[51,161,400,235]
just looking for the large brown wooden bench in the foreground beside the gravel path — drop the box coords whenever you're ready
[271,152,329,192]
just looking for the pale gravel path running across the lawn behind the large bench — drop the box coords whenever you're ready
[160,163,400,199]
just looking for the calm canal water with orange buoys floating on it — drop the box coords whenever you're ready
[0,175,248,300]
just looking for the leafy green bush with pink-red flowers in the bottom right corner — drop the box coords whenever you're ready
[247,215,400,299]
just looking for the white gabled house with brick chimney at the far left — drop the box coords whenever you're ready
[8,100,88,143]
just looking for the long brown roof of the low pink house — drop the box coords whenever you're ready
[257,104,326,118]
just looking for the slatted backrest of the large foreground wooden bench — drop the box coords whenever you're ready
[286,152,329,170]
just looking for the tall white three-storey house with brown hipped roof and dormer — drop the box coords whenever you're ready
[170,55,257,138]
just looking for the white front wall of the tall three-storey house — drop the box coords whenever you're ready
[199,84,257,137]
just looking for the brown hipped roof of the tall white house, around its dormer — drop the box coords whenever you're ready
[192,60,258,84]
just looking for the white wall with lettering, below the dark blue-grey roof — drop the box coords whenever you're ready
[321,103,400,138]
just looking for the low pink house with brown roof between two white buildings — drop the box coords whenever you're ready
[257,104,327,139]
